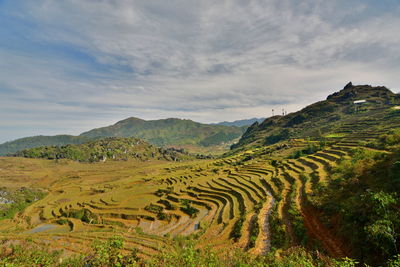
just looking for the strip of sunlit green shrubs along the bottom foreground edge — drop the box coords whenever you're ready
[0,236,364,267]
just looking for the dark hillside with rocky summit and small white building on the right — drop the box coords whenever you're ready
[232,83,400,149]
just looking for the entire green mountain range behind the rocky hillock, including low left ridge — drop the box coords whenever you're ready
[0,117,246,156]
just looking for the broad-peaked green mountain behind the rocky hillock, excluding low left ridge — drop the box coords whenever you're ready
[80,117,245,146]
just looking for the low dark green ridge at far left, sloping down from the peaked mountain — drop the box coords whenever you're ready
[0,135,93,156]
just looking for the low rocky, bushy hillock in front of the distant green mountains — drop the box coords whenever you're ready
[14,137,190,162]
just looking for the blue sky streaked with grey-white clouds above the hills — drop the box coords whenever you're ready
[0,0,400,143]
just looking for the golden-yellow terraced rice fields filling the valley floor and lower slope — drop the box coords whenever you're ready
[0,127,390,257]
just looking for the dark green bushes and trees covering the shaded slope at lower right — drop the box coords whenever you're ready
[312,149,400,265]
